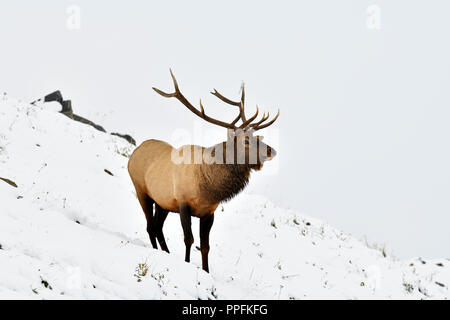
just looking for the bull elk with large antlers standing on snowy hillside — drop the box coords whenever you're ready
[128,70,280,272]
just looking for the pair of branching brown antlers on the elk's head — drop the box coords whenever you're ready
[153,69,280,131]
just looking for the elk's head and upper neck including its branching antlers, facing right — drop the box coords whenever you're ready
[153,70,280,170]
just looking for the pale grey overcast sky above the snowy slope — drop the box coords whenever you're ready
[0,0,450,258]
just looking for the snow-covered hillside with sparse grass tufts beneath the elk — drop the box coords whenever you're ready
[0,96,450,299]
